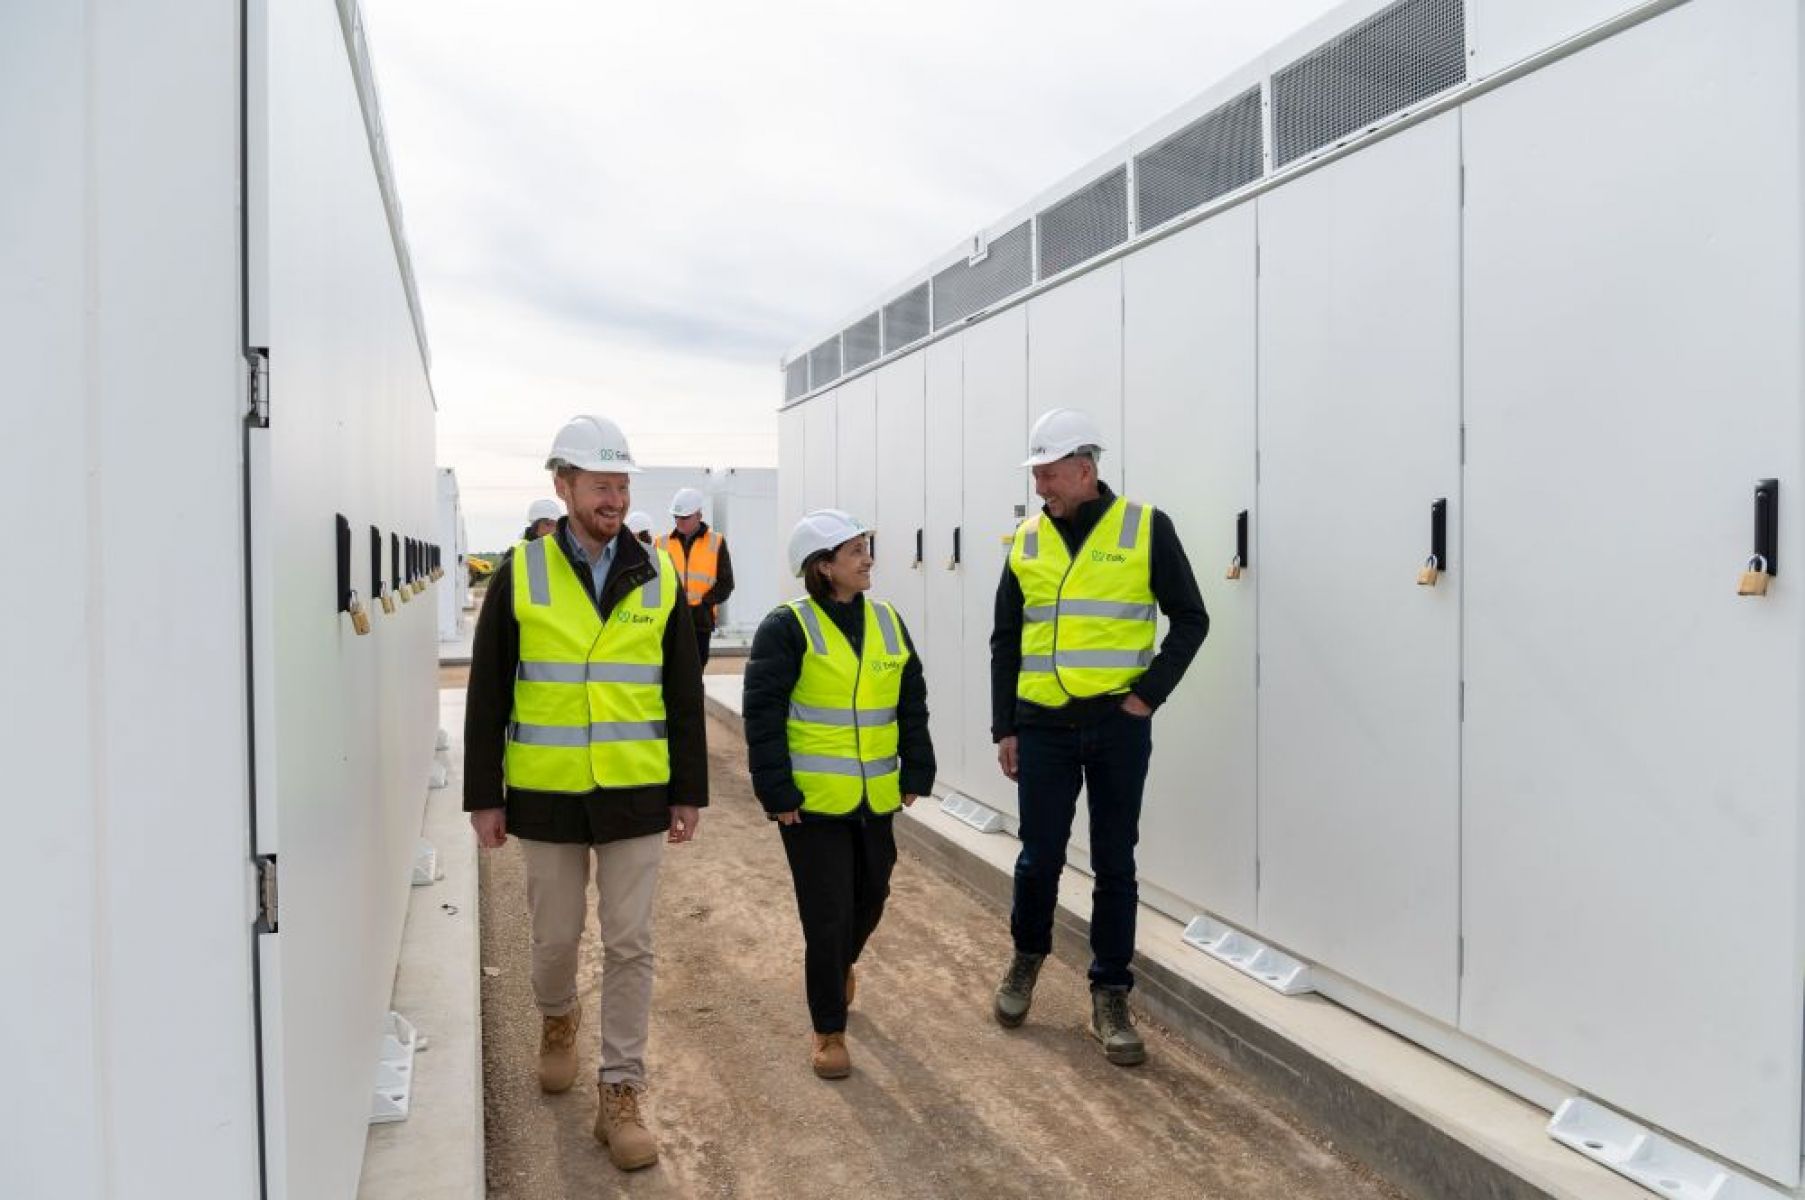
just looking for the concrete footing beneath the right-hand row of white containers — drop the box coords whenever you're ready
[704,675,1648,1200]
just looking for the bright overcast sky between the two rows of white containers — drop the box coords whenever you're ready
[361,0,1334,549]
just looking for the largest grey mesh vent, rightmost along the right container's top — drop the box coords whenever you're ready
[1273,0,1466,166]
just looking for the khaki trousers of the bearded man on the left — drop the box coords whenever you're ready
[520,834,664,1086]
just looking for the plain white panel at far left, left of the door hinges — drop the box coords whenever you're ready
[0,0,263,1200]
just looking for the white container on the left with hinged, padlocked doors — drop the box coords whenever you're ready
[0,0,442,1198]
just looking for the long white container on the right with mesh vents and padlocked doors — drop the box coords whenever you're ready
[780,0,1805,1189]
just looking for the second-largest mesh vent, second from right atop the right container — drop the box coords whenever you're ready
[1134,85,1264,229]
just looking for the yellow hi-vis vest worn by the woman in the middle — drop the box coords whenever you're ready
[787,597,910,816]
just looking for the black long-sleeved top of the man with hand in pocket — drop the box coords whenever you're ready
[991,482,1209,742]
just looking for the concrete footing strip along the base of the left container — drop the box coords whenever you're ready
[357,691,484,1200]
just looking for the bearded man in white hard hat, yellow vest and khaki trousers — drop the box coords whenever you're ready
[464,417,708,1169]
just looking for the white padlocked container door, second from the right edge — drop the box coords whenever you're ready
[1254,114,1466,1023]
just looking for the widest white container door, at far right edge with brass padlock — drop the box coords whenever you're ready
[1460,0,1805,1186]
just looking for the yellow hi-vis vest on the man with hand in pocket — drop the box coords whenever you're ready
[1009,496,1159,709]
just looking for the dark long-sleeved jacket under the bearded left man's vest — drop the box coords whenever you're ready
[464,518,708,845]
